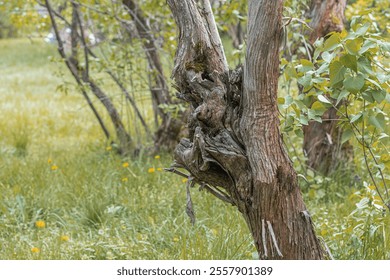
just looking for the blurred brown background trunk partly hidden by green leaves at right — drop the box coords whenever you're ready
[303,0,352,175]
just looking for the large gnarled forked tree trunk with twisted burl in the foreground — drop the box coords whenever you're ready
[168,0,323,259]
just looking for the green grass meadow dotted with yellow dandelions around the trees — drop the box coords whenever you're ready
[0,39,390,259]
